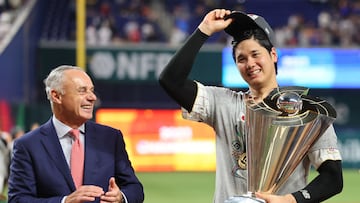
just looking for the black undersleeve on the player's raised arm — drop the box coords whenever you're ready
[159,29,209,112]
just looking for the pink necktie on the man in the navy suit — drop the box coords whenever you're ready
[70,129,84,188]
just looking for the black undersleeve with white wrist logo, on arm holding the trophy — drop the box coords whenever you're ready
[292,160,343,203]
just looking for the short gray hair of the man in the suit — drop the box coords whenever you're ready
[44,65,83,104]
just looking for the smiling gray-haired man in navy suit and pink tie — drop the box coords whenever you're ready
[9,66,144,203]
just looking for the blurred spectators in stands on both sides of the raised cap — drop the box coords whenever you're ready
[80,0,360,47]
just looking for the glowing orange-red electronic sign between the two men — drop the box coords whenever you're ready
[96,109,215,171]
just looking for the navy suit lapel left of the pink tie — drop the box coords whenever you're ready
[41,119,75,190]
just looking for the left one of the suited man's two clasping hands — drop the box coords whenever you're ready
[65,185,104,203]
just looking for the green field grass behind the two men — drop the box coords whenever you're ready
[137,170,360,203]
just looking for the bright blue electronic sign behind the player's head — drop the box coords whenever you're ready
[222,47,360,89]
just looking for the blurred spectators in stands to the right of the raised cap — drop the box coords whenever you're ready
[275,0,360,47]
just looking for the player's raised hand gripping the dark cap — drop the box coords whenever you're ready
[198,9,232,36]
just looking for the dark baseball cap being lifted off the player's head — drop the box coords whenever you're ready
[225,11,275,46]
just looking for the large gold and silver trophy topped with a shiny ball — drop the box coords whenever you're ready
[225,87,336,203]
